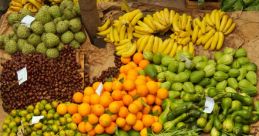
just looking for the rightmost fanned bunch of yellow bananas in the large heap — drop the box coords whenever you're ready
[192,10,236,50]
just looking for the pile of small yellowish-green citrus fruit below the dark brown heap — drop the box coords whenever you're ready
[2,100,81,136]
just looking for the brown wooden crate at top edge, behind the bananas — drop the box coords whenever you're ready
[185,0,221,9]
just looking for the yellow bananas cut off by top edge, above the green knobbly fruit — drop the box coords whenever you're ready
[8,0,44,13]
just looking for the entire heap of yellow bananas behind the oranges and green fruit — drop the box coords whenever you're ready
[97,8,238,57]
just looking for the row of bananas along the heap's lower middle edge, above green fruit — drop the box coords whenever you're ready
[136,35,194,57]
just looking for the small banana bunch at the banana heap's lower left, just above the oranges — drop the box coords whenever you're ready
[115,39,137,57]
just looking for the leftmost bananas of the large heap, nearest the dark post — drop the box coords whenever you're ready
[97,9,143,44]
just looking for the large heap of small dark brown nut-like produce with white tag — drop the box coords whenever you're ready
[0,48,82,112]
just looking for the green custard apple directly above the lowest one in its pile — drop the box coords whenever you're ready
[43,33,60,48]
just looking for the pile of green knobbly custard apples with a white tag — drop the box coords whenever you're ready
[0,0,86,58]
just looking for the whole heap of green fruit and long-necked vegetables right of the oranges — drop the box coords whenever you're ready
[144,48,259,136]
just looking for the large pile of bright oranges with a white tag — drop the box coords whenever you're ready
[57,53,168,136]
